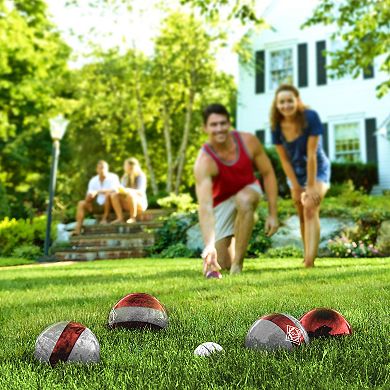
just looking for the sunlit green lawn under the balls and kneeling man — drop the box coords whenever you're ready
[0,258,390,390]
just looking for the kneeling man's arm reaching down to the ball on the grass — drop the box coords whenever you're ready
[194,154,220,273]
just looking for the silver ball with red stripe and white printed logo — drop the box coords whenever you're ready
[245,313,309,350]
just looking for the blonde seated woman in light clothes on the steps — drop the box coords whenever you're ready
[111,158,148,224]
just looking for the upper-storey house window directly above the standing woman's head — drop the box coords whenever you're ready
[269,49,294,90]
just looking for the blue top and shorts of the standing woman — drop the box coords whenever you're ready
[272,110,330,187]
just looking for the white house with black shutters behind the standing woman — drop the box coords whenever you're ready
[237,0,390,192]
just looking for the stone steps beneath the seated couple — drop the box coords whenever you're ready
[53,210,169,261]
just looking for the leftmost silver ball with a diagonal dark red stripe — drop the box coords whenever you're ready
[35,322,100,367]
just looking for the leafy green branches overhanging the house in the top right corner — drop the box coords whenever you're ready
[303,0,390,97]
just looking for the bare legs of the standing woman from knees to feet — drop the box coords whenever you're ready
[302,182,329,267]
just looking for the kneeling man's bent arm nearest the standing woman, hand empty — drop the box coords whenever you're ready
[251,135,279,236]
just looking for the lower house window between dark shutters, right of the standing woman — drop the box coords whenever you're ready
[334,122,361,162]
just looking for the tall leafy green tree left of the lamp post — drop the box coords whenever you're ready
[0,0,70,216]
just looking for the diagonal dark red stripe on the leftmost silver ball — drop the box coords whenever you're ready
[49,322,86,367]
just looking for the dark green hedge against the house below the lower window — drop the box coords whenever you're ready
[331,162,378,194]
